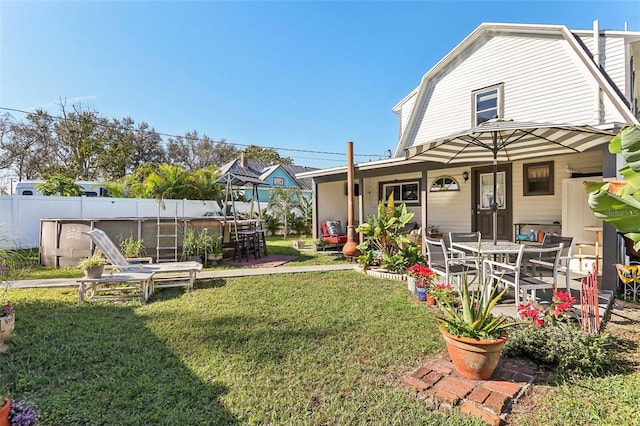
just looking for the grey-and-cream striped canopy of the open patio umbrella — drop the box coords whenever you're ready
[405,119,615,164]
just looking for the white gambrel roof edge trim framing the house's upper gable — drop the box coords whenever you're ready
[393,23,640,157]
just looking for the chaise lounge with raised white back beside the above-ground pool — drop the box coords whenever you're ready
[83,229,202,296]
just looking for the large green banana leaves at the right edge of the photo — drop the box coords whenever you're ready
[585,126,640,251]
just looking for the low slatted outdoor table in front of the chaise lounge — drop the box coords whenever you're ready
[76,272,154,305]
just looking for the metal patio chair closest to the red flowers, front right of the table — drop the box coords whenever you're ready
[482,243,563,306]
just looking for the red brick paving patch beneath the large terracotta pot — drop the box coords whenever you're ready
[403,354,535,426]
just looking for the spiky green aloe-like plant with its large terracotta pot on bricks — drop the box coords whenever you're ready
[432,276,521,380]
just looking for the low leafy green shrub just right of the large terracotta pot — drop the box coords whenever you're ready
[503,324,613,373]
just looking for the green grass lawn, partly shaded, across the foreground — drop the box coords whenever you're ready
[5,248,640,425]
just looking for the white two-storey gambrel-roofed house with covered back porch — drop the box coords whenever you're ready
[298,21,640,292]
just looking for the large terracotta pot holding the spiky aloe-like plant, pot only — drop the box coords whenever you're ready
[438,327,507,380]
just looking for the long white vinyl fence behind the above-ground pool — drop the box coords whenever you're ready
[0,195,267,248]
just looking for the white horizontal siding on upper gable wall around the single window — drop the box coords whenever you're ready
[408,35,621,145]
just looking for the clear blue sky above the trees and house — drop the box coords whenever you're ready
[0,0,640,168]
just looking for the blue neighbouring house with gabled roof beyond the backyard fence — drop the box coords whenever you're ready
[220,152,318,202]
